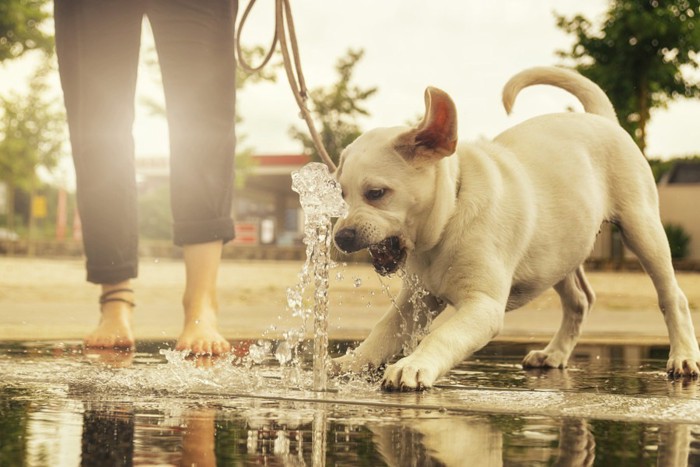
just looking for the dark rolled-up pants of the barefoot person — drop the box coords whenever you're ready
[54,0,238,284]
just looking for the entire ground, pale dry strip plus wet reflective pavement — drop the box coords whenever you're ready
[0,258,700,467]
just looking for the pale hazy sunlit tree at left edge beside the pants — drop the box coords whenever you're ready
[0,61,65,236]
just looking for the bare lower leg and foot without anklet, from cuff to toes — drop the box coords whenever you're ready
[175,241,231,355]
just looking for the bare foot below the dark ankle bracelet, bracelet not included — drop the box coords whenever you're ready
[83,302,135,349]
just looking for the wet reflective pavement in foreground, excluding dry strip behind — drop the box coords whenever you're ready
[0,341,700,466]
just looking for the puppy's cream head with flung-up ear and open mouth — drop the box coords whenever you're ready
[334,88,457,274]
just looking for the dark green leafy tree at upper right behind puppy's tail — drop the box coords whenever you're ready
[557,0,700,156]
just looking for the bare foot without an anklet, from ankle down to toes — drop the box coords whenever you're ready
[175,308,231,355]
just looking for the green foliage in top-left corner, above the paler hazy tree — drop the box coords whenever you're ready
[0,0,53,62]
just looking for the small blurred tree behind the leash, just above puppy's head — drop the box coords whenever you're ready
[290,50,377,162]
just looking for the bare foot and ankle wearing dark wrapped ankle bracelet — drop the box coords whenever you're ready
[83,280,135,350]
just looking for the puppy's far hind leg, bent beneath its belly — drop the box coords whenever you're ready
[523,266,595,368]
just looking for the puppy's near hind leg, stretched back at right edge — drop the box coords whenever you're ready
[619,214,700,377]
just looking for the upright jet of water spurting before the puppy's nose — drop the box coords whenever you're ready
[288,162,347,391]
